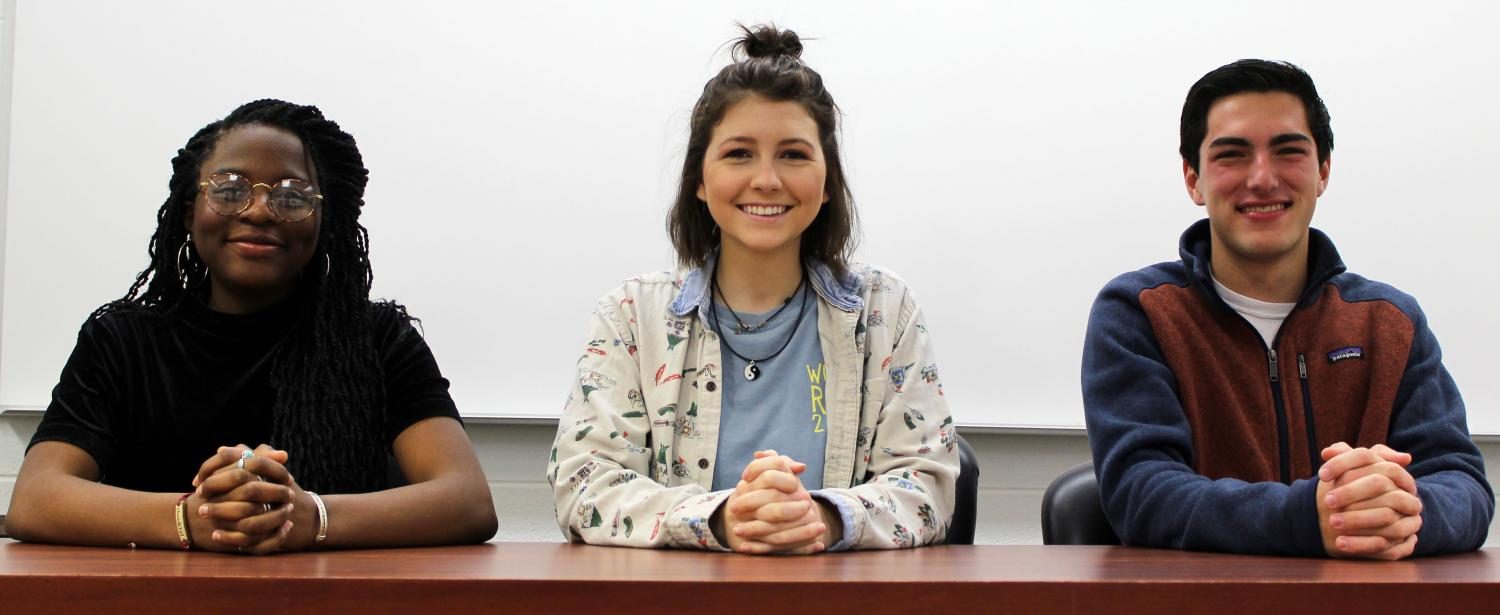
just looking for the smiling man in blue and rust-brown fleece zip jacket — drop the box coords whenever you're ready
[1083,60,1494,560]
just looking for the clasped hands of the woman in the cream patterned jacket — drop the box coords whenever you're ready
[711,450,843,555]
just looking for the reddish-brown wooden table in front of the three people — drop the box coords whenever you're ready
[0,540,1500,615]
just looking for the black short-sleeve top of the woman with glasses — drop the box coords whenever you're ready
[29,299,459,492]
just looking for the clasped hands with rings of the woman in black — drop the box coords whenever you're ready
[185,444,317,555]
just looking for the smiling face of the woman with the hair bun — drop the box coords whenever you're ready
[698,96,828,265]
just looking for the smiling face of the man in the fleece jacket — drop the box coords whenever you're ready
[1182,92,1329,276]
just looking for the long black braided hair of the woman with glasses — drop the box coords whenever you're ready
[93,99,411,492]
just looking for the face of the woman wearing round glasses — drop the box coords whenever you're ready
[185,125,323,314]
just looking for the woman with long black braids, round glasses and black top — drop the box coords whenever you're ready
[6,101,497,554]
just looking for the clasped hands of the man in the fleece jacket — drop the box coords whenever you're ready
[1317,443,1422,560]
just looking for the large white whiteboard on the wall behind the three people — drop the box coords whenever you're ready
[0,0,1500,434]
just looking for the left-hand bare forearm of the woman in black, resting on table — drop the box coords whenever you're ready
[6,474,184,549]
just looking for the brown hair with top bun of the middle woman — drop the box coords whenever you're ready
[666,26,857,276]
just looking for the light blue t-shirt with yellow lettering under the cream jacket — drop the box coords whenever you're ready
[710,284,828,491]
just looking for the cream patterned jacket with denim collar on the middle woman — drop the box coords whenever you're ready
[548,266,959,551]
